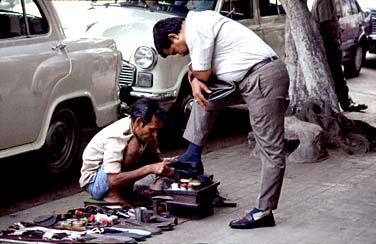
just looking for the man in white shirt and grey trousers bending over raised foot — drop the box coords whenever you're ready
[153,11,289,229]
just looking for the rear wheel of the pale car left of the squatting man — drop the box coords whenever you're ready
[42,109,80,174]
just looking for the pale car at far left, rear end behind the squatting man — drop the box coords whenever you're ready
[0,0,121,174]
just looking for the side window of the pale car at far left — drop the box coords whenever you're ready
[0,0,49,39]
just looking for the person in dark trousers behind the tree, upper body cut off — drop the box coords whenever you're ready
[311,0,368,112]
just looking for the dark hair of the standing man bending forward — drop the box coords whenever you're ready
[153,17,185,58]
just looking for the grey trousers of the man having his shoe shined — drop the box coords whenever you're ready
[184,59,289,210]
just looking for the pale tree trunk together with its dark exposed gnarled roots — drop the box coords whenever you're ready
[280,0,376,154]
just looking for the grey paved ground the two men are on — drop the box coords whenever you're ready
[0,56,376,244]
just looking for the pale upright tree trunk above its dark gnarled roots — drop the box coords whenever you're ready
[281,0,339,113]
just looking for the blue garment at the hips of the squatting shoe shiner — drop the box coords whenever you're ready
[85,164,110,200]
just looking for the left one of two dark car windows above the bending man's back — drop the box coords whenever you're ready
[220,0,253,20]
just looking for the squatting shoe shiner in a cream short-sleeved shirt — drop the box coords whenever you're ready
[79,98,174,205]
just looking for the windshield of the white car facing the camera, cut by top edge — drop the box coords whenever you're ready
[92,0,217,16]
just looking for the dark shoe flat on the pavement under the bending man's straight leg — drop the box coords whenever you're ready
[230,208,275,229]
